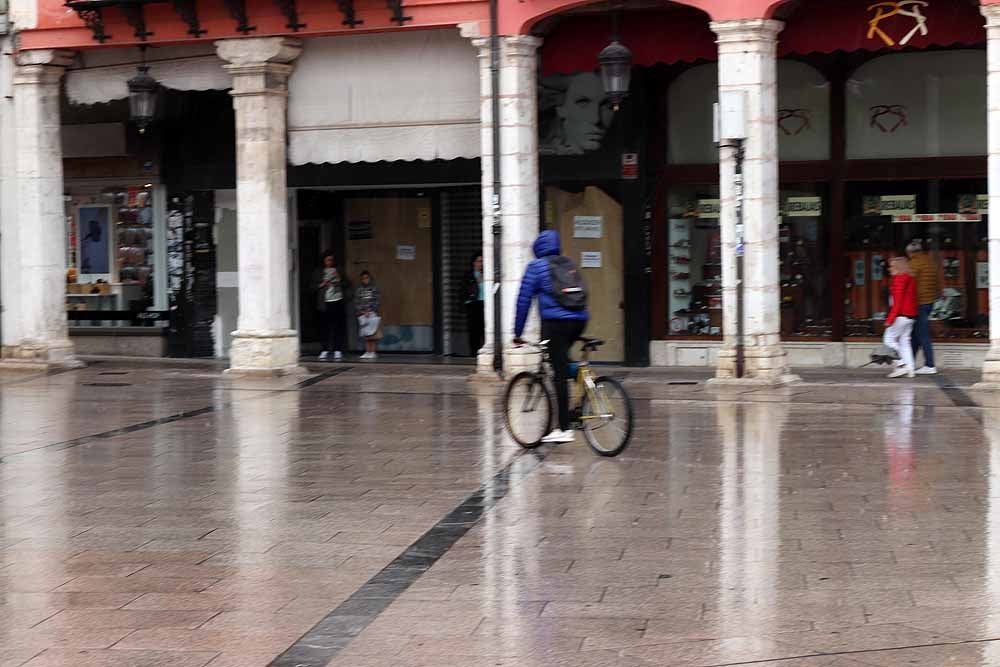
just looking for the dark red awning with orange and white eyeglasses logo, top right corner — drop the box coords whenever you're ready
[778,0,986,56]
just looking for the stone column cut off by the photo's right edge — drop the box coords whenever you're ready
[977,5,1000,389]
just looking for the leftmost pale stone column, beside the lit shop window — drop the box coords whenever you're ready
[0,49,81,368]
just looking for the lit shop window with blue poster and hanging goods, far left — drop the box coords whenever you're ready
[66,185,160,326]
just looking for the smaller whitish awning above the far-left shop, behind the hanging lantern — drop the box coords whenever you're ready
[66,44,233,104]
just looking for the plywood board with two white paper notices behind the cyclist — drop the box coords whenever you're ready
[546,186,625,361]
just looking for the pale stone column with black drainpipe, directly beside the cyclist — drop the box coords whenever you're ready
[472,35,542,376]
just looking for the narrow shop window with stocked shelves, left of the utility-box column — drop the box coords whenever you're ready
[666,185,722,337]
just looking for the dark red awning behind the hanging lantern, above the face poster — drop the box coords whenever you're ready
[542,6,716,76]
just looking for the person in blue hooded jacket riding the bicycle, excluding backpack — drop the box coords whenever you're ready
[514,230,590,442]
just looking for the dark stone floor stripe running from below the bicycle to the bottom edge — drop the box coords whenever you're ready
[268,450,545,667]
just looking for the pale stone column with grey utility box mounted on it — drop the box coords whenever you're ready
[712,19,794,383]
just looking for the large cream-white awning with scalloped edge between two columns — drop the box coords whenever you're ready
[288,29,481,165]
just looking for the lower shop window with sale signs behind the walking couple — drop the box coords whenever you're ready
[844,180,989,342]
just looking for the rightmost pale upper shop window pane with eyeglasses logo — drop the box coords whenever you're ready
[847,50,987,159]
